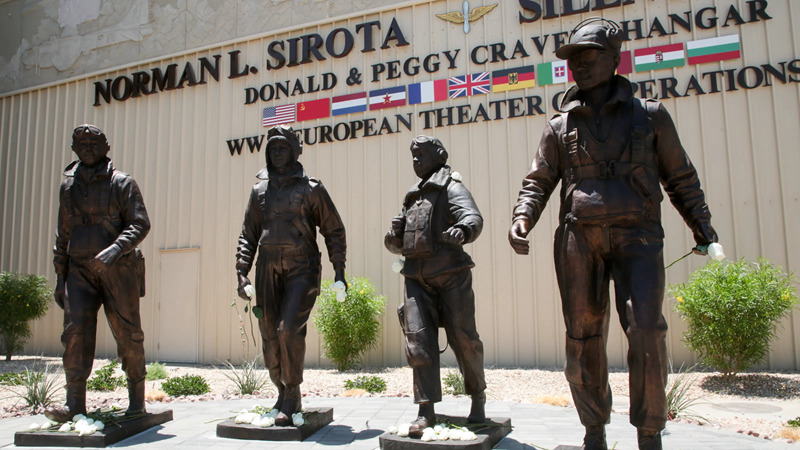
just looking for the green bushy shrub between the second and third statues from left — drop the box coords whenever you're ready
[314,278,386,371]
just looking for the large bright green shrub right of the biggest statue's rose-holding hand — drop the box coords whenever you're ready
[670,259,797,377]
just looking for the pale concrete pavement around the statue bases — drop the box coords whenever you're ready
[0,396,800,450]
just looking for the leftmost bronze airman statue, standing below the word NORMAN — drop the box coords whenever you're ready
[47,125,150,422]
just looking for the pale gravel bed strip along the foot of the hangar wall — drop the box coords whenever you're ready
[0,356,800,440]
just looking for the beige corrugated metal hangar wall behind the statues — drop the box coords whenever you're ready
[0,0,800,369]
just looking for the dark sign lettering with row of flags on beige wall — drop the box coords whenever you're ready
[89,0,800,155]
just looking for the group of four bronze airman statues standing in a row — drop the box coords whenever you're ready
[51,18,717,449]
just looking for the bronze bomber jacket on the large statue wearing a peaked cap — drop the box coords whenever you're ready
[513,76,711,242]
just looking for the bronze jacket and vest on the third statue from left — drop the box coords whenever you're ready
[384,166,483,278]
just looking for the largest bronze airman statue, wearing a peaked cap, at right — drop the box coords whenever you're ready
[508,18,717,449]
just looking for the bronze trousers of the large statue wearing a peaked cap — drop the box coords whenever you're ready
[554,222,668,430]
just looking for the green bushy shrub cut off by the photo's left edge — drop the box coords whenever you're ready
[0,272,53,361]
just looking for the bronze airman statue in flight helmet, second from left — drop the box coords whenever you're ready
[231,126,346,426]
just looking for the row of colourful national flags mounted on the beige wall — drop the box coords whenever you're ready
[261,34,741,127]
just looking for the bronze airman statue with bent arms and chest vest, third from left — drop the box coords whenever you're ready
[384,136,486,437]
